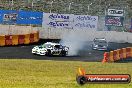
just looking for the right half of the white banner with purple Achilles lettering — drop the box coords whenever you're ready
[74,15,98,30]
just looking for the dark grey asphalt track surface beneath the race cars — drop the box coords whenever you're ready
[0,40,132,62]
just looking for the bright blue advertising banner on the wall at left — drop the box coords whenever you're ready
[0,10,43,25]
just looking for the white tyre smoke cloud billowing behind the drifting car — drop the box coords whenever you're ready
[60,30,93,56]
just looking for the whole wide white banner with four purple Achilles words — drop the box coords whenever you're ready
[42,13,98,30]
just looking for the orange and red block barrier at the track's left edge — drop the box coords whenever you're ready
[0,31,39,46]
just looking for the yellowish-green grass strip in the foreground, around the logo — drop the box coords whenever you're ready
[0,59,132,88]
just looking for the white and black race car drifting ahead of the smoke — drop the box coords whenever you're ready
[32,42,69,56]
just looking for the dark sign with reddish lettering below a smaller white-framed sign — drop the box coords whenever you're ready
[105,16,124,27]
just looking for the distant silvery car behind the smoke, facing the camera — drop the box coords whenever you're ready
[92,38,108,50]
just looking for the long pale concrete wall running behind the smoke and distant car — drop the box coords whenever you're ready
[39,27,132,43]
